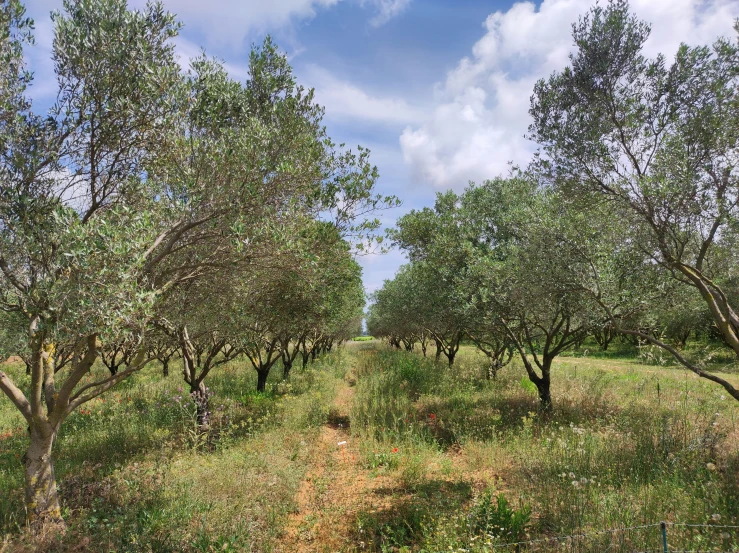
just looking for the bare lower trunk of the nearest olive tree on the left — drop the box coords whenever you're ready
[23,423,64,528]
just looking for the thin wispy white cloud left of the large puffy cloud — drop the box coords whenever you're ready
[305,65,423,125]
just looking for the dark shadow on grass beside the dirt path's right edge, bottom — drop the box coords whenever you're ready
[354,480,472,552]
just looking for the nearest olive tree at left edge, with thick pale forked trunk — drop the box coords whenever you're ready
[0,1,184,522]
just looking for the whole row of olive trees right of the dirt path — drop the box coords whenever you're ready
[368,0,739,408]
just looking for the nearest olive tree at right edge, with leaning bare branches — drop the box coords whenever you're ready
[529,0,739,400]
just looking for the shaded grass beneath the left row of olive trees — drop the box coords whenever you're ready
[0,392,284,536]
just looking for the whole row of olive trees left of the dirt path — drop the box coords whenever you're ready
[0,0,396,524]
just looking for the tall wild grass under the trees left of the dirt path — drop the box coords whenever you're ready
[0,352,349,553]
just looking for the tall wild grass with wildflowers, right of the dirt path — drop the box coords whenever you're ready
[353,349,739,551]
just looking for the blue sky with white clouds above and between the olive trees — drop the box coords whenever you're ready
[20,0,739,293]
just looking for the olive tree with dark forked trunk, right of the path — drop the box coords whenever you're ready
[466,179,603,410]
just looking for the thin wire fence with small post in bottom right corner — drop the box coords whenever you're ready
[489,522,739,553]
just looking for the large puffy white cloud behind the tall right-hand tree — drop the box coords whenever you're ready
[400,0,739,188]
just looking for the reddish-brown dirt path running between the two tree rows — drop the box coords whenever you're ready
[278,376,394,553]
